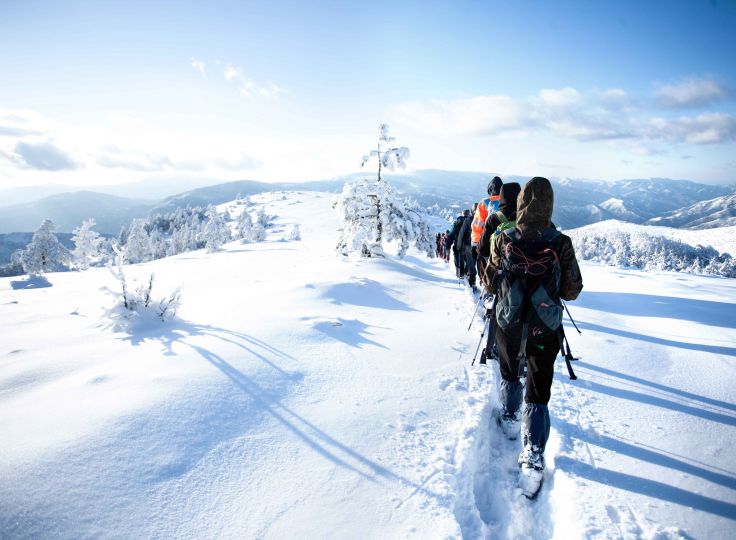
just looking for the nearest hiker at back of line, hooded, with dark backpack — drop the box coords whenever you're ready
[486,177,583,497]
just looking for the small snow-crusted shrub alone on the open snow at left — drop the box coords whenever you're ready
[104,243,181,331]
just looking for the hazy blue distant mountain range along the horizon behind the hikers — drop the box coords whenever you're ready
[0,169,736,234]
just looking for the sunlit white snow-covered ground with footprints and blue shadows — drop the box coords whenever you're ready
[0,193,736,539]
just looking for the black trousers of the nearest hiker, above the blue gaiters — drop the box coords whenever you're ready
[496,326,560,405]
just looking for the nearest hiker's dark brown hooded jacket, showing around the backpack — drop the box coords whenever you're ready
[486,176,583,300]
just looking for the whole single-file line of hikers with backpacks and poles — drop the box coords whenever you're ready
[436,176,583,499]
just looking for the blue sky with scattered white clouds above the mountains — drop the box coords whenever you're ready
[0,0,736,186]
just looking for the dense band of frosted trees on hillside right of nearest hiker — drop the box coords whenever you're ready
[568,227,736,277]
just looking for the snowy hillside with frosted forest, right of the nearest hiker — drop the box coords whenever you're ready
[566,220,736,278]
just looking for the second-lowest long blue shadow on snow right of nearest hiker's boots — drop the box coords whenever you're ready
[555,419,736,490]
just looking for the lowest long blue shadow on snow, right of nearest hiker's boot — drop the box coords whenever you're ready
[555,456,736,520]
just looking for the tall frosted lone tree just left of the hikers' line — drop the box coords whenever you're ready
[335,124,433,257]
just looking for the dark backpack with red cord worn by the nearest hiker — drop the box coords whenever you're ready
[496,227,563,339]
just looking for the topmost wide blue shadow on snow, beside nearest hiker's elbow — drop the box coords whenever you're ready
[575,291,736,328]
